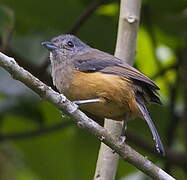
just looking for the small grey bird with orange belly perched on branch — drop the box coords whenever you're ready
[42,34,165,155]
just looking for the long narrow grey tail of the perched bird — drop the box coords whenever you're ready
[136,98,165,156]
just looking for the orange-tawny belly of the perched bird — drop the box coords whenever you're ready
[66,72,139,120]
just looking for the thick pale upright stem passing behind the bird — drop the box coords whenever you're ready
[94,0,141,180]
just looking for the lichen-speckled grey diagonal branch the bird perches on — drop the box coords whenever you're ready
[0,53,174,180]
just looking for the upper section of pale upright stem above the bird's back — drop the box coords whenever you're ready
[115,0,141,65]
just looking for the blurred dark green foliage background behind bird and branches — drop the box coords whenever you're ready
[0,0,187,180]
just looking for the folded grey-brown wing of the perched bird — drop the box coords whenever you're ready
[73,51,159,90]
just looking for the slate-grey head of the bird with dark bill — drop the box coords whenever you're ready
[42,34,89,58]
